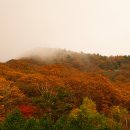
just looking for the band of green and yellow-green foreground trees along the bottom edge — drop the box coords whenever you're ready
[0,98,126,130]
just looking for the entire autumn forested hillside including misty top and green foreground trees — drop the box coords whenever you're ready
[0,49,130,130]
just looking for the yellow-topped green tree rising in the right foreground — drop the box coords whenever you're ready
[69,98,121,130]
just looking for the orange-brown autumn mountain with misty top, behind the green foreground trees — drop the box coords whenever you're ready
[0,48,130,129]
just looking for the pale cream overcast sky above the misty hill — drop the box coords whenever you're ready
[0,0,130,61]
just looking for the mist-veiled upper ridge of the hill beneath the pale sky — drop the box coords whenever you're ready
[16,48,130,70]
